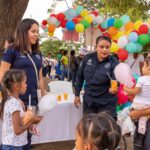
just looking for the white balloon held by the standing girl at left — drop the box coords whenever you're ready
[38,94,57,115]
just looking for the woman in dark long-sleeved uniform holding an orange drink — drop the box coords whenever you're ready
[74,36,118,119]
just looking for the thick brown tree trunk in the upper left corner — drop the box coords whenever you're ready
[0,0,29,50]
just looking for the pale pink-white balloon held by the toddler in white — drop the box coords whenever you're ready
[114,63,134,87]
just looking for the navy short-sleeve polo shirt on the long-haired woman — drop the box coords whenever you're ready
[2,49,42,101]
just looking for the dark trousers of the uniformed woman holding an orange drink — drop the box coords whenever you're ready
[83,100,117,120]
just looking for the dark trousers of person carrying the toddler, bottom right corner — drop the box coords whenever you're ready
[133,119,150,150]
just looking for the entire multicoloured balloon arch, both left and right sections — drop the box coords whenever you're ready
[41,6,150,60]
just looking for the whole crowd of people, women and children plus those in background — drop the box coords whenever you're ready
[0,19,150,150]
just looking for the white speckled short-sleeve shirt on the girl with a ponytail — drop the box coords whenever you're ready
[2,97,27,146]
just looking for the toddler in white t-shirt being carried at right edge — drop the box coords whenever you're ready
[124,57,150,134]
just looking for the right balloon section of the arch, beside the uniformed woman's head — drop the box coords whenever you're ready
[105,15,150,60]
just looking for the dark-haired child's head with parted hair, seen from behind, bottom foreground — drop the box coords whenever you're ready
[75,112,121,150]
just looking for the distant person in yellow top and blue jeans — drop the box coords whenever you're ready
[60,50,68,80]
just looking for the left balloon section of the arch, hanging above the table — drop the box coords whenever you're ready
[41,6,106,36]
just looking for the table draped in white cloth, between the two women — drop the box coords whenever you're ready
[0,95,82,144]
